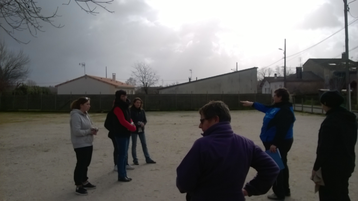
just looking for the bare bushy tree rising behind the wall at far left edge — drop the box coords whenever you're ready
[0,41,30,92]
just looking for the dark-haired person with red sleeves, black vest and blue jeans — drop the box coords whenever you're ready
[111,90,136,182]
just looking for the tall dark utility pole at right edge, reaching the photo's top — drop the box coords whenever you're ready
[343,0,352,111]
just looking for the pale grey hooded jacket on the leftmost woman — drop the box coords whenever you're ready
[70,109,93,149]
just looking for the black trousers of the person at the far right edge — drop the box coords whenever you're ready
[319,172,350,201]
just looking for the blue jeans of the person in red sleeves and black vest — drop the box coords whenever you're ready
[115,137,129,178]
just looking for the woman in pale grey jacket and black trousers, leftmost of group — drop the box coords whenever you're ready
[70,97,98,195]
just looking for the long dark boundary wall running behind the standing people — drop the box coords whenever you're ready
[0,94,271,112]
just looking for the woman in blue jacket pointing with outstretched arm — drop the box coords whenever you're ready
[241,88,296,200]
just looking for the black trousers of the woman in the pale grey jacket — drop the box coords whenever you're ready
[73,146,93,186]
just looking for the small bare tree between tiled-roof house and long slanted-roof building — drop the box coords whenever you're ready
[132,62,159,94]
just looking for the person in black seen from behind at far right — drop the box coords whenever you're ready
[312,91,357,201]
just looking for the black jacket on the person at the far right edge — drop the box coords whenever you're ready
[313,107,357,175]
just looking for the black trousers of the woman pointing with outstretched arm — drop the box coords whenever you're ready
[264,139,293,198]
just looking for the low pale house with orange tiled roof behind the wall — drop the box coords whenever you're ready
[55,73,135,94]
